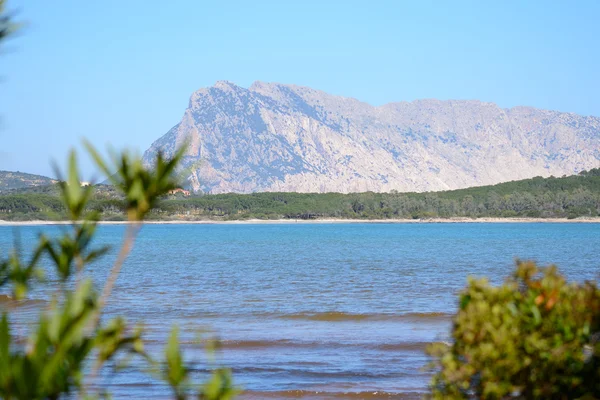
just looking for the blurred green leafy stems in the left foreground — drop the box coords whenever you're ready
[0,147,235,400]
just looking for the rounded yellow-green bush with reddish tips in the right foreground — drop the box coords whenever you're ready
[429,262,600,399]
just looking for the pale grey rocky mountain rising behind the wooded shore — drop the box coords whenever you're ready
[144,81,600,193]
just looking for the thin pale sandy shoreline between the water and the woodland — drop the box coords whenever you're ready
[0,217,600,226]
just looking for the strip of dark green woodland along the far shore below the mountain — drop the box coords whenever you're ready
[0,168,600,221]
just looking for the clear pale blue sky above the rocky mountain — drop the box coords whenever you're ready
[0,0,600,175]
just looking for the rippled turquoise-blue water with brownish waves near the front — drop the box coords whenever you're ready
[0,223,600,398]
